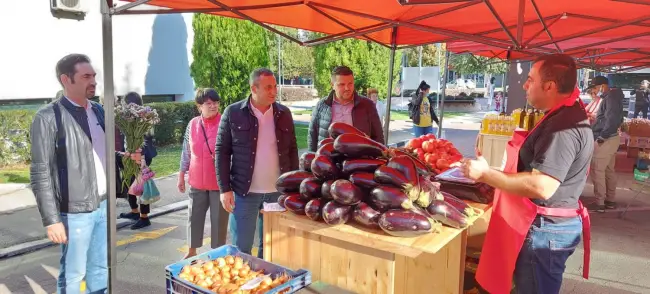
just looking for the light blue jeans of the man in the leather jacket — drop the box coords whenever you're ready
[57,200,108,294]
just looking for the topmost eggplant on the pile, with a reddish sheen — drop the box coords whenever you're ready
[334,134,388,158]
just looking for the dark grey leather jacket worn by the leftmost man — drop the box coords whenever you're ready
[30,98,106,226]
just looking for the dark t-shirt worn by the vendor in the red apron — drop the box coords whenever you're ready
[517,102,594,215]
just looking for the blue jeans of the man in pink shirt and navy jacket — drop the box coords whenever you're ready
[228,192,280,258]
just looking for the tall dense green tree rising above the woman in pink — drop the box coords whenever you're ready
[190,14,269,110]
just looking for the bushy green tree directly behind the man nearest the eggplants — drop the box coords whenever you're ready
[314,39,401,97]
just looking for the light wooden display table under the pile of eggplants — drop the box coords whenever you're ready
[264,205,485,294]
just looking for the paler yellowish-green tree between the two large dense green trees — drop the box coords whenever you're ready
[268,26,314,79]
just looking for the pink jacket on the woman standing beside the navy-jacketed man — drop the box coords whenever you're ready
[181,114,221,191]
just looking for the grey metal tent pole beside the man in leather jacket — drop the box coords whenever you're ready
[99,0,117,293]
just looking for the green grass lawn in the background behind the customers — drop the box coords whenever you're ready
[0,124,309,184]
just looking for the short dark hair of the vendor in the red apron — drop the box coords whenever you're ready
[533,54,578,94]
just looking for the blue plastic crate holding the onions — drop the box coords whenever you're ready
[165,245,311,294]
